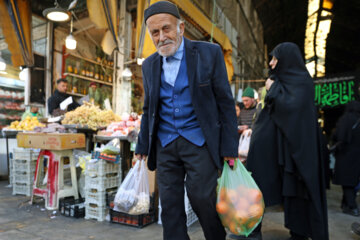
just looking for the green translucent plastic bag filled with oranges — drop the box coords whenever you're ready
[216,159,265,237]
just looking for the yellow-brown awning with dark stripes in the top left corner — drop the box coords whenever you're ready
[0,0,34,67]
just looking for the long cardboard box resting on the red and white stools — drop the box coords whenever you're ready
[16,133,85,150]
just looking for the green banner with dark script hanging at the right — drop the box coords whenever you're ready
[315,78,355,107]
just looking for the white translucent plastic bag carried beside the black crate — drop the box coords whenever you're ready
[114,161,150,215]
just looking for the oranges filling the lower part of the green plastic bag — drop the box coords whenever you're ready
[216,186,264,235]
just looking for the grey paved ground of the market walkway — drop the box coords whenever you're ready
[0,181,360,240]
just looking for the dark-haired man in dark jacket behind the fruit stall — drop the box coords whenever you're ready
[48,78,80,116]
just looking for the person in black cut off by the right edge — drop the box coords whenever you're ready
[333,101,360,216]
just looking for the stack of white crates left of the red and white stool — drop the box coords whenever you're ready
[11,148,39,196]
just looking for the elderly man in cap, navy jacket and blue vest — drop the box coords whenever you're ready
[135,1,238,240]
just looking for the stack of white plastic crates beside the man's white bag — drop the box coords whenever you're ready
[85,159,121,221]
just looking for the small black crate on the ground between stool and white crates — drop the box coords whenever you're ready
[59,198,85,218]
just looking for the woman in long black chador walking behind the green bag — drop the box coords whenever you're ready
[247,43,329,240]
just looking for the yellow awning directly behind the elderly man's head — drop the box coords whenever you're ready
[136,0,234,81]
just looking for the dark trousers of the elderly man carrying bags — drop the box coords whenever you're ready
[156,137,226,240]
